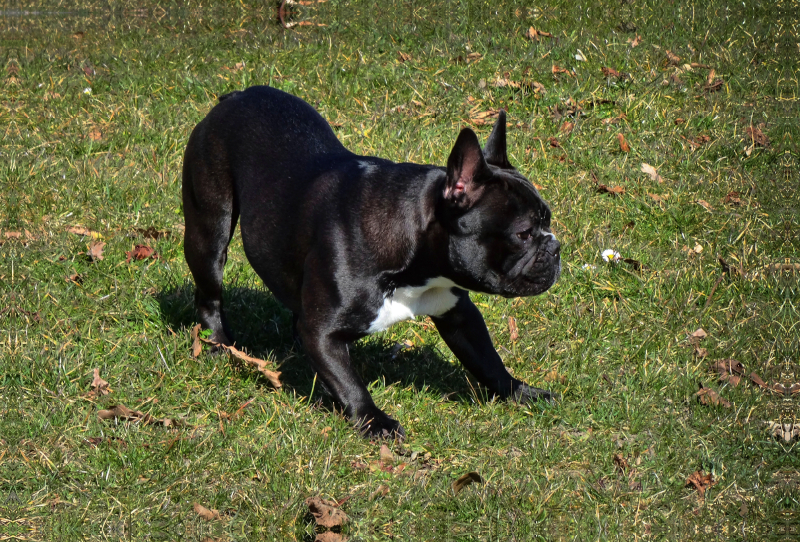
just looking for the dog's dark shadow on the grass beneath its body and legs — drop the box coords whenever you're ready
[156,283,474,408]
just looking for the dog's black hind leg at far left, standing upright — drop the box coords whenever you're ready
[183,127,239,345]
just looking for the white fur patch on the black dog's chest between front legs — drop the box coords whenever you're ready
[367,277,458,333]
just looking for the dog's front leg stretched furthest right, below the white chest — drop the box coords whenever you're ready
[431,294,552,403]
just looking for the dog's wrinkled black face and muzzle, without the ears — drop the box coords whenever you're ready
[447,166,561,297]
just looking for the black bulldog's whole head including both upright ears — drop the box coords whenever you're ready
[437,111,561,297]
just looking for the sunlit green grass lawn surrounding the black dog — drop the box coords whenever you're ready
[0,0,800,540]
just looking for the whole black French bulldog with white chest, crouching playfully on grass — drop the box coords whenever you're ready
[183,86,561,437]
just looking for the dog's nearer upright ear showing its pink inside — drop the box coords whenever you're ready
[444,128,490,209]
